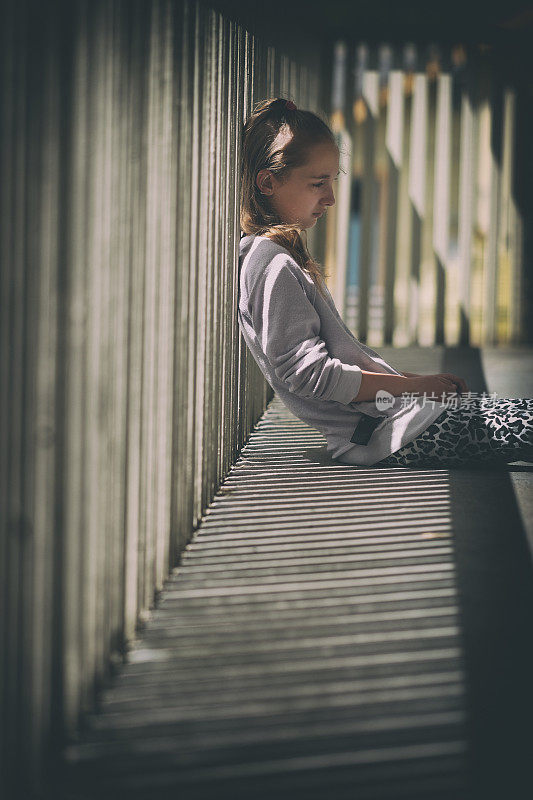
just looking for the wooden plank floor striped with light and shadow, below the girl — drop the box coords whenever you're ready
[51,349,533,800]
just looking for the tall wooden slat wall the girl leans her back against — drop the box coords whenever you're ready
[0,0,328,797]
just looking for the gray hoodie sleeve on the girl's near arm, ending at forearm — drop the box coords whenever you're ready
[249,257,362,405]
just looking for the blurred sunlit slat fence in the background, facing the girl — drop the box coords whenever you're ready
[328,44,527,346]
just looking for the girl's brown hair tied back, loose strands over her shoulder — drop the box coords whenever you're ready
[240,97,337,295]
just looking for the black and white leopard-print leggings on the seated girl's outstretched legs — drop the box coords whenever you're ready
[376,398,533,467]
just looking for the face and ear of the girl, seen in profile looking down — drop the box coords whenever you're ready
[256,143,340,228]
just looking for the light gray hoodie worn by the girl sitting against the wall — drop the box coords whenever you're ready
[238,236,446,466]
